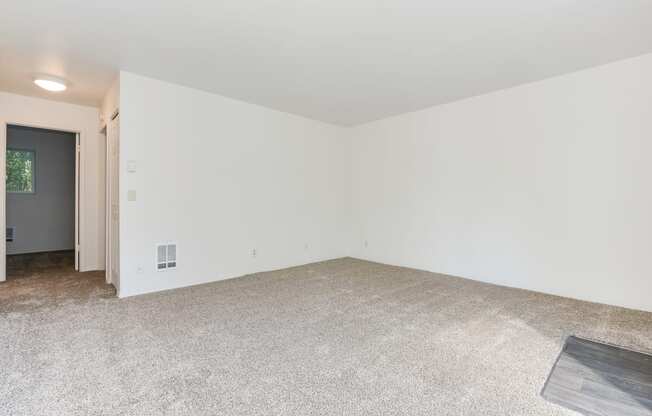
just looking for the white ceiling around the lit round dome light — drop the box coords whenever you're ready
[0,0,652,125]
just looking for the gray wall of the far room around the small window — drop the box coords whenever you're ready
[7,126,75,254]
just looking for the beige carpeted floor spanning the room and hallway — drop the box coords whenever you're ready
[0,259,652,415]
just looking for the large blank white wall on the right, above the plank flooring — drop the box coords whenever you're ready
[350,55,652,311]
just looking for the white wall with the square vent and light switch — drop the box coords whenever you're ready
[120,72,351,296]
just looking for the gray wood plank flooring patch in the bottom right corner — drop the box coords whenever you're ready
[542,337,652,416]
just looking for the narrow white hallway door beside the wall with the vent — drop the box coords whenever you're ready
[106,115,120,293]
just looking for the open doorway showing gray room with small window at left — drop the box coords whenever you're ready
[4,124,80,279]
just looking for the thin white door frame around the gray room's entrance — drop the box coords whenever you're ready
[0,120,86,282]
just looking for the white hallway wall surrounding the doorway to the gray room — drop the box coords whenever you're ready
[0,92,104,271]
